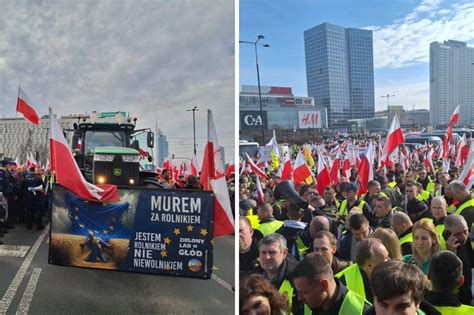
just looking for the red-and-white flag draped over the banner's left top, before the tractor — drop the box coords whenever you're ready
[49,108,120,202]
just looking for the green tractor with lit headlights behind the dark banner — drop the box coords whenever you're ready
[72,112,162,187]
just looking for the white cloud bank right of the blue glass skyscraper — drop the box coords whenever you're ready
[367,0,474,68]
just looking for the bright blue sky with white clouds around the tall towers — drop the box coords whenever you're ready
[239,0,474,110]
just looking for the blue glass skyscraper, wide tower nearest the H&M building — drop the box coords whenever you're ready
[304,23,375,128]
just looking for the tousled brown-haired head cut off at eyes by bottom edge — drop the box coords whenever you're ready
[364,260,440,315]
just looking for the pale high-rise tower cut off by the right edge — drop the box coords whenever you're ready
[430,40,474,126]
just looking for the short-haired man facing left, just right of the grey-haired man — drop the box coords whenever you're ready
[313,230,351,274]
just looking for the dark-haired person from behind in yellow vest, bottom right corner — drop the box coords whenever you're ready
[425,251,474,315]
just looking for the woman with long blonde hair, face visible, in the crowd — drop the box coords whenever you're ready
[403,220,440,275]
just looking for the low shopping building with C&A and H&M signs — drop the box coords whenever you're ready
[239,85,327,130]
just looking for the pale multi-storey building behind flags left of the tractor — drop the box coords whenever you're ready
[0,116,79,165]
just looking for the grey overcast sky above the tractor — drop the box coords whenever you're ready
[0,0,235,165]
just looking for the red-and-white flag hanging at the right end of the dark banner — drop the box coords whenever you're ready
[200,110,234,237]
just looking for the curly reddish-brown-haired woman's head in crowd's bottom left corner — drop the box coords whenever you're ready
[239,274,289,315]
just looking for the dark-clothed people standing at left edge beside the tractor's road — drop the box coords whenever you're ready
[0,160,54,244]
